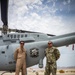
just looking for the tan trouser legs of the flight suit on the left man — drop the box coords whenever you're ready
[15,59,26,75]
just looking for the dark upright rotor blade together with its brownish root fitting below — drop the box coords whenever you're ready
[0,0,9,34]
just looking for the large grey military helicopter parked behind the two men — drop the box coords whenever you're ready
[0,0,75,72]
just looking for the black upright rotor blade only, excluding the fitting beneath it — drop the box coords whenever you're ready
[0,0,9,26]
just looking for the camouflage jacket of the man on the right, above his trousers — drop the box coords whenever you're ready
[45,47,60,63]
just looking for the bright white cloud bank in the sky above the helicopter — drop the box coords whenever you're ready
[9,0,63,34]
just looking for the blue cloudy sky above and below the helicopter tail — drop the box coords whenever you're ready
[0,0,75,66]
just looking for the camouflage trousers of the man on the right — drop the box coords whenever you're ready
[44,63,57,75]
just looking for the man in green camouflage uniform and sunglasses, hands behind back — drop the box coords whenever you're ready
[45,41,60,75]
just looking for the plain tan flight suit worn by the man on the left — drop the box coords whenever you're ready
[14,48,26,75]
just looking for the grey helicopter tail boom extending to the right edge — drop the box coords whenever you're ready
[49,33,75,47]
